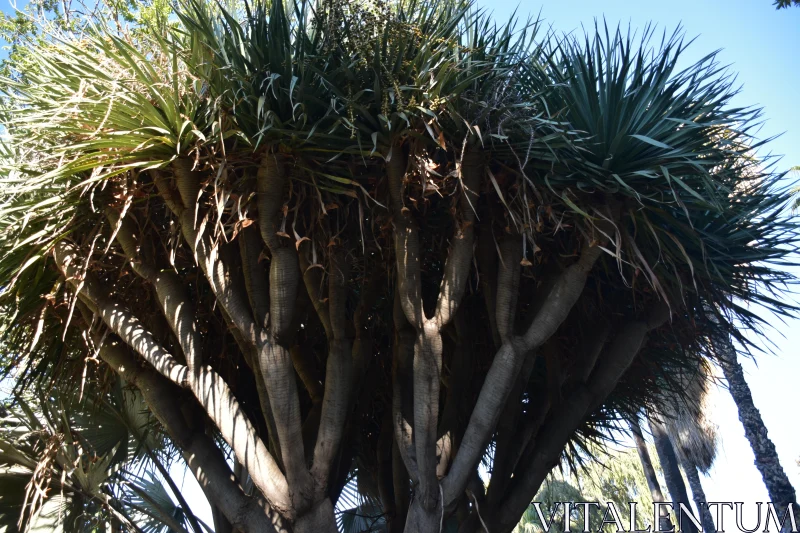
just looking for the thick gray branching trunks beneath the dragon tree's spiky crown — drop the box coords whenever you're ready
[53,148,688,533]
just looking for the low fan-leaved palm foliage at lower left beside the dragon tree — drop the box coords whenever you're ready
[0,376,208,533]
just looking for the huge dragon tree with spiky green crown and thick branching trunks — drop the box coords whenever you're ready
[0,0,798,533]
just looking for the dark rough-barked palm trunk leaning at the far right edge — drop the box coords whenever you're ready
[719,339,800,523]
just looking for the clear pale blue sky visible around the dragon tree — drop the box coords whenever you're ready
[0,0,800,529]
